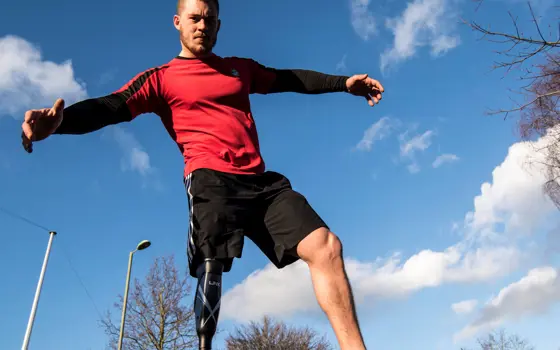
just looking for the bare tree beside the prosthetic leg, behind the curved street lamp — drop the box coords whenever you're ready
[101,256,198,350]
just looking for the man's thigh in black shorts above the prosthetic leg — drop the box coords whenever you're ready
[185,169,251,277]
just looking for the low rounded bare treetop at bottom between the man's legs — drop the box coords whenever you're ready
[226,317,333,350]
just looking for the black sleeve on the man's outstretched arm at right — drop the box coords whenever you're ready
[268,68,348,94]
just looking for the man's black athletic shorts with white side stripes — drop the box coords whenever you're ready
[184,169,328,277]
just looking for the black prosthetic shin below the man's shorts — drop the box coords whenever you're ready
[194,259,224,350]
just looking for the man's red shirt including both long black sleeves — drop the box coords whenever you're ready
[56,54,347,175]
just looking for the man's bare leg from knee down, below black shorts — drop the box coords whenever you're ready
[297,228,366,350]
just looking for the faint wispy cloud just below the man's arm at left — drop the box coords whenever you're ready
[111,126,154,176]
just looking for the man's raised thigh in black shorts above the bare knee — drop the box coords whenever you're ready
[247,172,328,268]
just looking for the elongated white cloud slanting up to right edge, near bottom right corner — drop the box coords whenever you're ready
[454,266,560,341]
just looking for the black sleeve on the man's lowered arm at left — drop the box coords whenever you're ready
[54,94,133,135]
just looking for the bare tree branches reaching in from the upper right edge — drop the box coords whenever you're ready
[468,0,560,205]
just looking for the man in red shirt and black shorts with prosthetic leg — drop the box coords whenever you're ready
[22,0,383,350]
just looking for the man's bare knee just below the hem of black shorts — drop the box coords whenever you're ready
[297,228,342,264]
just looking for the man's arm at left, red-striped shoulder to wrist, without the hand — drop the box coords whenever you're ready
[54,68,166,135]
